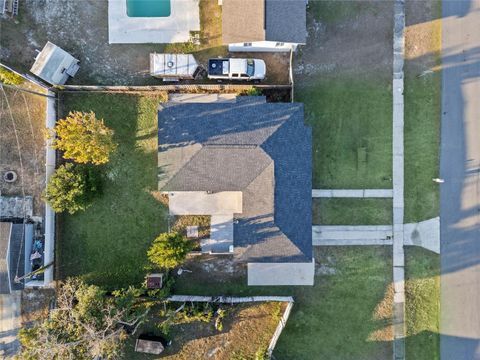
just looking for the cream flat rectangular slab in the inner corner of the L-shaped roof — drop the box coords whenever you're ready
[168,191,242,215]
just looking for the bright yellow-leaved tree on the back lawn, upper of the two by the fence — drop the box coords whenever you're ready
[49,111,117,165]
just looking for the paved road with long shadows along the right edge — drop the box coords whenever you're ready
[440,0,480,360]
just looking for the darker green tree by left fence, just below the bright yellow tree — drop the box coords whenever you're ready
[43,163,101,214]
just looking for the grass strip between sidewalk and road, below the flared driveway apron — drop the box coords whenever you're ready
[405,246,440,360]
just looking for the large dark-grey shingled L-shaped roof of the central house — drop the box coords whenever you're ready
[158,97,312,262]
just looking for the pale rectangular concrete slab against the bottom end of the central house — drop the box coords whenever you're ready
[247,260,315,286]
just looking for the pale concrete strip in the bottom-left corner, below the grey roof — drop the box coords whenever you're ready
[0,291,21,359]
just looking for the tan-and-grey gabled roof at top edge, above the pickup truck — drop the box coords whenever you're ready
[222,0,307,44]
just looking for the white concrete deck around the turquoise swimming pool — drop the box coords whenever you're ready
[108,0,200,44]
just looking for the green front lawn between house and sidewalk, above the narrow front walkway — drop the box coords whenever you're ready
[295,77,392,189]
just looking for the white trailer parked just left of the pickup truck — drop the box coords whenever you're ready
[150,53,198,81]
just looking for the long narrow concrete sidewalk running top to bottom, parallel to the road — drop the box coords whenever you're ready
[392,0,405,360]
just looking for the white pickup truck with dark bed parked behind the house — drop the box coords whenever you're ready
[208,59,266,81]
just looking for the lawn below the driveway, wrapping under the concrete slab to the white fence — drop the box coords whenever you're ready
[174,246,393,360]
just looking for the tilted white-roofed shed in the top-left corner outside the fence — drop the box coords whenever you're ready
[30,41,80,85]
